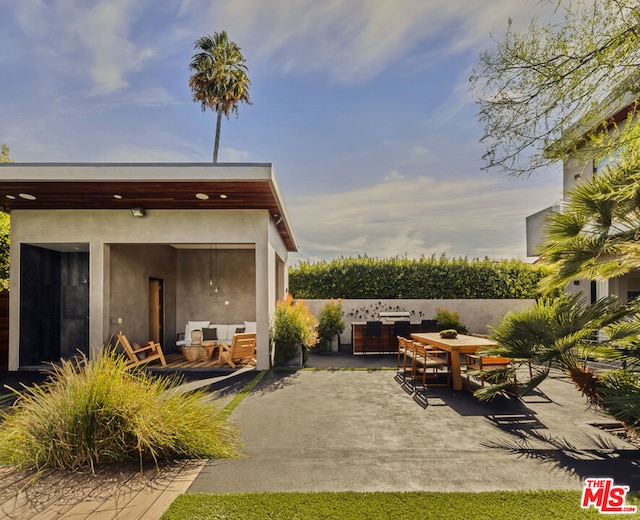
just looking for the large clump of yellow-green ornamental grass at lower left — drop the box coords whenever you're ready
[0,349,239,470]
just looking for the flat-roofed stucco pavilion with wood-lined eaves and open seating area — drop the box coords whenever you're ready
[0,163,297,370]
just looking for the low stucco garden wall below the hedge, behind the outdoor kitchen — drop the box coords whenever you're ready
[305,300,535,344]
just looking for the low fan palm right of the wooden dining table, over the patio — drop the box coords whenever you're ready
[476,295,640,428]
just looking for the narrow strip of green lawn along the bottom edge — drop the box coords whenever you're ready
[162,491,640,520]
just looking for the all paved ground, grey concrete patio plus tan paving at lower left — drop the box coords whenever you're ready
[0,354,640,520]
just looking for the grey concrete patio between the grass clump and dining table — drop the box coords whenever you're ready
[189,355,640,493]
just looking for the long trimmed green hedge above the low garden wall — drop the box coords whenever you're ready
[289,256,549,300]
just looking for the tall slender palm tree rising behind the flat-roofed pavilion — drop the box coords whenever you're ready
[189,31,251,162]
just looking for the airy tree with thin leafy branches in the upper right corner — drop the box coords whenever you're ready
[470,0,640,175]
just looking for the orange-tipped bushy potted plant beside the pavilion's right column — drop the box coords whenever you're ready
[270,294,318,366]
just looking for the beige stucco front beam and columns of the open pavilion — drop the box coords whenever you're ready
[9,210,287,370]
